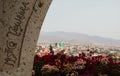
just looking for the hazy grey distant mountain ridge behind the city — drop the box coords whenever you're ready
[38,32,120,45]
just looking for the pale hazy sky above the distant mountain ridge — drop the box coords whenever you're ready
[41,0,120,39]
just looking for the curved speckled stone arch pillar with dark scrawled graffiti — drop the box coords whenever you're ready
[0,0,51,76]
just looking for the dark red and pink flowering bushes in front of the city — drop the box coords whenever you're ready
[33,51,120,76]
